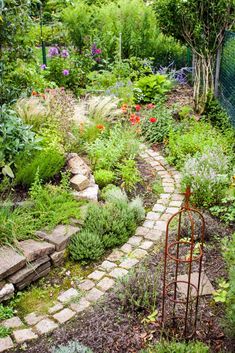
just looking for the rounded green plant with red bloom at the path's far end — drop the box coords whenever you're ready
[141,105,174,143]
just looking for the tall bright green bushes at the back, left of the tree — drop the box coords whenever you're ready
[64,0,186,65]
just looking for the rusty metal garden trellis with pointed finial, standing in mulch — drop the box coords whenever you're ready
[162,187,205,338]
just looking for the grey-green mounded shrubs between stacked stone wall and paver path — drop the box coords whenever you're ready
[70,187,144,260]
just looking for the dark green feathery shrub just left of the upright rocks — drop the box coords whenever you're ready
[15,148,65,186]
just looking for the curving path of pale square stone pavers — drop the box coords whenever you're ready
[0,145,184,352]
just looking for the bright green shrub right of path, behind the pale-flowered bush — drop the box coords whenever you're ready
[167,120,234,168]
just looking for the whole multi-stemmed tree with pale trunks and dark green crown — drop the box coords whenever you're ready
[155,0,235,113]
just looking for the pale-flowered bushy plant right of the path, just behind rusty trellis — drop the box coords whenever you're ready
[182,148,230,206]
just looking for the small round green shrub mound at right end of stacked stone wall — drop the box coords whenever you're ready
[69,229,104,262]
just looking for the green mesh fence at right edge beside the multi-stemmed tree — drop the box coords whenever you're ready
[218,32,235,126]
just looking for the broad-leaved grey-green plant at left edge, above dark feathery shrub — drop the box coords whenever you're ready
[0,106,38,177]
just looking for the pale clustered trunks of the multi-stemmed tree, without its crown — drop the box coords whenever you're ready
[193,53,215,114]
